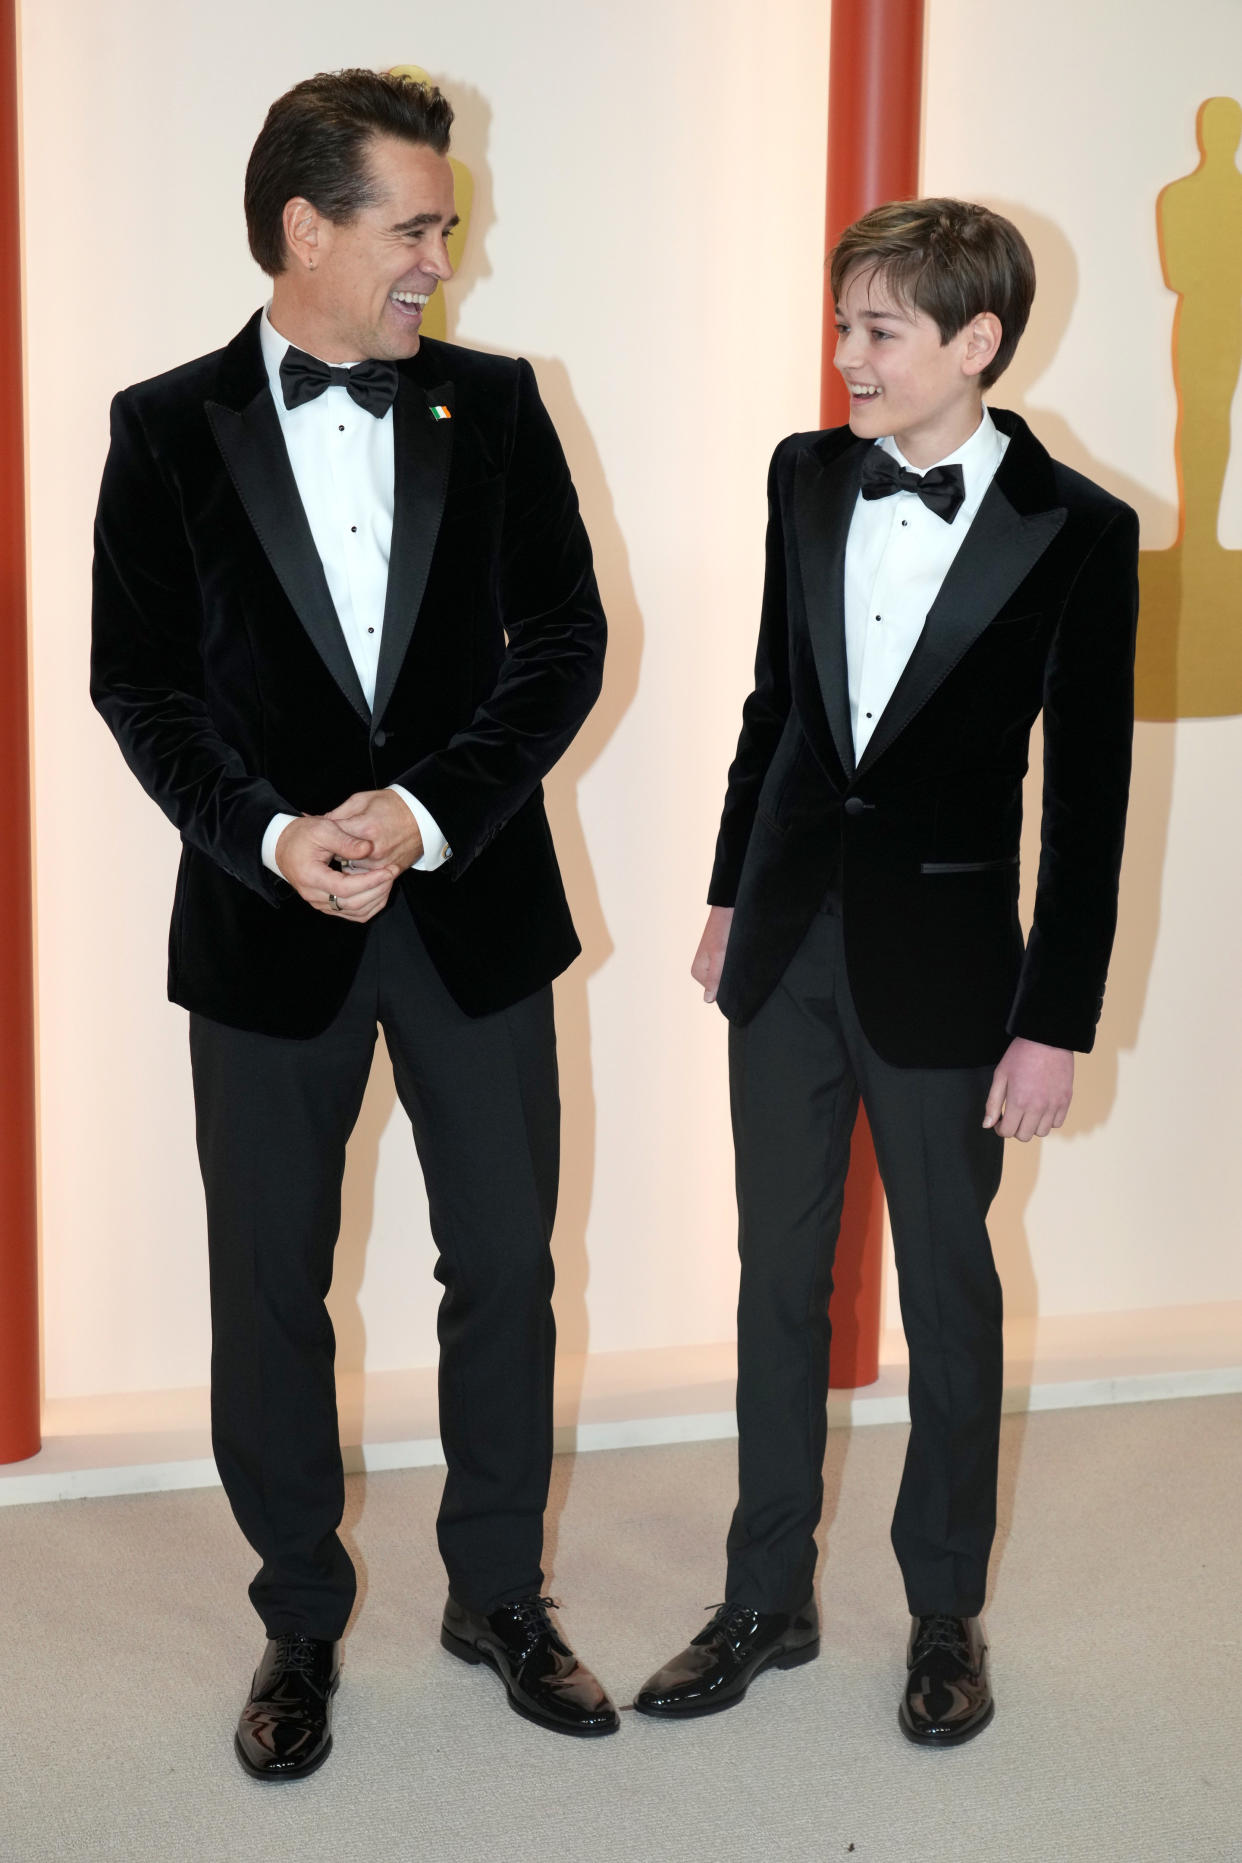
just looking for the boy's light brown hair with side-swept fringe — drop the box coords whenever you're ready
[829,199,1035,388]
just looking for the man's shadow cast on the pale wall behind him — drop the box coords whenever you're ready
[330,67,642,1408]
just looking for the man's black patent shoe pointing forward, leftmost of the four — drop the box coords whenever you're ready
[233,1630,341,1779]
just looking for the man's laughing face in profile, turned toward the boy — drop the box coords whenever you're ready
[290,136,456,361]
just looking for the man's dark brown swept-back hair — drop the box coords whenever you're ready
[246,71,452,278]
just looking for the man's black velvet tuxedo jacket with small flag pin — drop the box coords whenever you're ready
[91,317,605,1036]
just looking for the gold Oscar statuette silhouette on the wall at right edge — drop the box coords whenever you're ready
[1134,97,1242,719]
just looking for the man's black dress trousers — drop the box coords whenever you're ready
[190,894,560,1638]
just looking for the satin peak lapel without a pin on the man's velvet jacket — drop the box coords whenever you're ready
[207,382,371,725]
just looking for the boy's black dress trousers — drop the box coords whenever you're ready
[726,905,1004,1617]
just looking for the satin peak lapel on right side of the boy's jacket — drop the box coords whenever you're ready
[858,481,1065,775]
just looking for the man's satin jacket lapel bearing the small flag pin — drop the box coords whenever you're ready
[374,376,452,725]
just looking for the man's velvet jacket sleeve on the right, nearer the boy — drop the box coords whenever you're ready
[385,361,607,879]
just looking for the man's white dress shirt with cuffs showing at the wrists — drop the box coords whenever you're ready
[259,306,452,874]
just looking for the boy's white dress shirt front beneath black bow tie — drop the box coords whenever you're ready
[845,408,1009,758]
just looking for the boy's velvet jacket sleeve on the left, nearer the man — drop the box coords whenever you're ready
[708,440,791,905]
